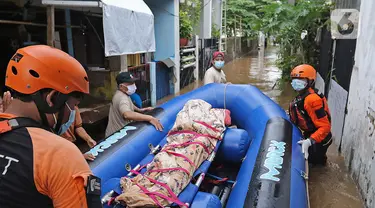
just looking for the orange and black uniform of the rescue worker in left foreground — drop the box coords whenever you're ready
[0,113,92,208]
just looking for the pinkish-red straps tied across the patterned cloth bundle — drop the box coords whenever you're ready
[125,121,221,207]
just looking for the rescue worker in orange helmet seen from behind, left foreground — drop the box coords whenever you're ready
[0,45,101,208]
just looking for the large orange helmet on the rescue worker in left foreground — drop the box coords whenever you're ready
[5,45,89,94]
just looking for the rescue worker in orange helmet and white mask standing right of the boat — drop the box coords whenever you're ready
[289,64,332,165]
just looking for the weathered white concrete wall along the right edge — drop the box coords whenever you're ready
[342,0,375,207]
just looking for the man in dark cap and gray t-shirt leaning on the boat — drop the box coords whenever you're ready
[105,72,163,137]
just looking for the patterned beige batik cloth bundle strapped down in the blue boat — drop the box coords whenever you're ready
[116,100,230,207]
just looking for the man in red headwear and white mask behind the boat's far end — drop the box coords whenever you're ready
[204,51,227,85]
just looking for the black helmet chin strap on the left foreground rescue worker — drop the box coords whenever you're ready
[32,92,69,133]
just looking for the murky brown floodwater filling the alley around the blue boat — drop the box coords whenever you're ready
[159,48,363,208]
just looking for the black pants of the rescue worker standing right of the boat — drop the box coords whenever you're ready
[309,134,332,165]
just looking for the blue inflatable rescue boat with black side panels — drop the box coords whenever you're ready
[89,84,308,208]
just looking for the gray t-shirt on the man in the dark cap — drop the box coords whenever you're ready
[105,90,134,137]
